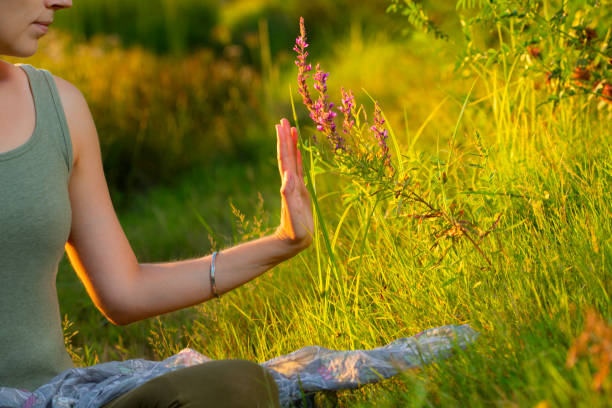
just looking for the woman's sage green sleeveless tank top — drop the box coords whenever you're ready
[0,64,73,391]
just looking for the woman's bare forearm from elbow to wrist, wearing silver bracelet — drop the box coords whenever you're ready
[112,234,303,324]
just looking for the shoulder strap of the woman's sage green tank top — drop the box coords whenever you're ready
[19,64,73,174]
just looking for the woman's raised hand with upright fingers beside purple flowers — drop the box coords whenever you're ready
[275,118,314,250]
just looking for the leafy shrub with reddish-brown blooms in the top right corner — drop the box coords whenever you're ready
[388,0,612,108]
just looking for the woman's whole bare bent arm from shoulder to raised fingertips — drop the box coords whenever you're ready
[56,77,313,325]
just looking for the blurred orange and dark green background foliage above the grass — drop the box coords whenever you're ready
[14,0,457,206]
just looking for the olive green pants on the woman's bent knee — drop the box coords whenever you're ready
[103,360,279,408]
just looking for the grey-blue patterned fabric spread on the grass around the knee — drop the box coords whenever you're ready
[0,325,478,408]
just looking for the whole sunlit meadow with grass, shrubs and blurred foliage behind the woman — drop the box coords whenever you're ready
[14,0,612,408]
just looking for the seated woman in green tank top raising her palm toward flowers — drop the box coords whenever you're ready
[0,0,313,408]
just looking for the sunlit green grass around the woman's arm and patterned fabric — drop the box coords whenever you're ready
[53,4,612,407]
